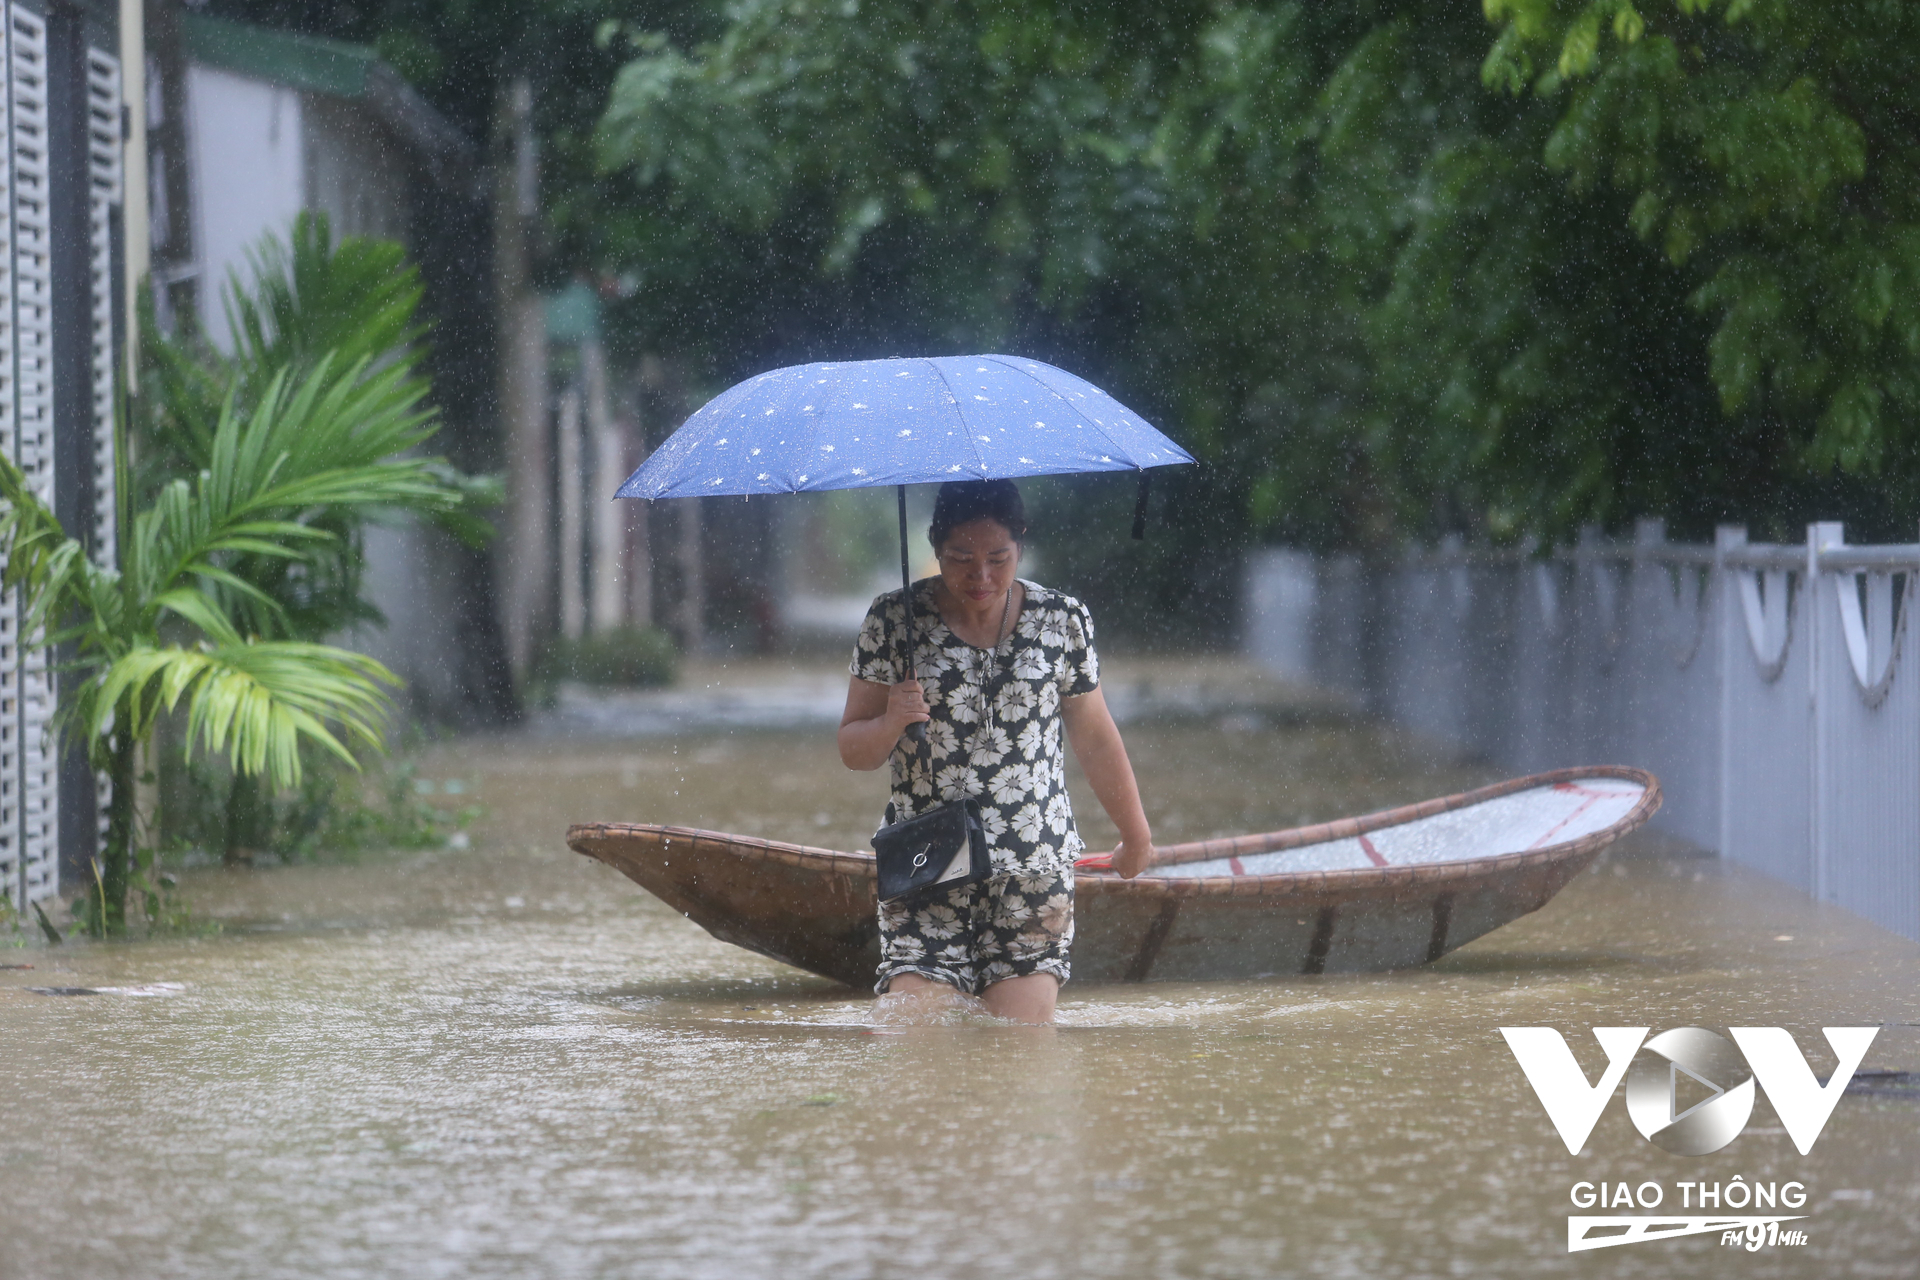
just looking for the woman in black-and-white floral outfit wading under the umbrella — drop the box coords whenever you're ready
[839,480,1154,1023]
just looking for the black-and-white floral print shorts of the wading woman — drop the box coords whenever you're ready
[874,867,1073,996]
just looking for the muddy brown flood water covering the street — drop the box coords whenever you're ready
[0,671,1920,1280]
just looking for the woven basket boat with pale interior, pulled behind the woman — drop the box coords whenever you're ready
[566,766,1661,986]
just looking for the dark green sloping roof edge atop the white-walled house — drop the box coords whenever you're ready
[180,13,478,190]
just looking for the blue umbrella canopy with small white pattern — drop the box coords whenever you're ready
[618,355,1192,499]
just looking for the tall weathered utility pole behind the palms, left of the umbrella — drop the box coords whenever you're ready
[493,77,553,685]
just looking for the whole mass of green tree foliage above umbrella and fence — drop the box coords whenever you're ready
[599,0,1920,572]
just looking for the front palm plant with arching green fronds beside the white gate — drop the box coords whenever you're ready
[0,347,463,933]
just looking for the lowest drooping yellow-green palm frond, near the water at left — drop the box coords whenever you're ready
[99,641,399,787]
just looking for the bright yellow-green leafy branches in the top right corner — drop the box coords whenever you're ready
[1484,0,1920,485]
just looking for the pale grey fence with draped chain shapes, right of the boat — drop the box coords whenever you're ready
[1246,520,1920,938]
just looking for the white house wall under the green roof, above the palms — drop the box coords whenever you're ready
[186,65,305,351]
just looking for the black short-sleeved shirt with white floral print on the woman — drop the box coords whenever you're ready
[851,578,1100,875]
